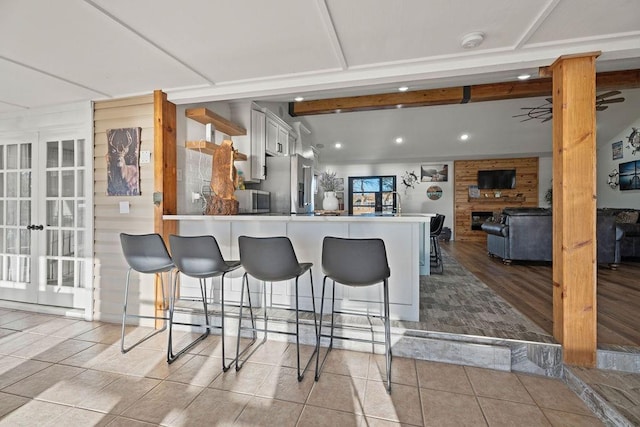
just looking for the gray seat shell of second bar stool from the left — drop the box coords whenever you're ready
[169,235,228,278]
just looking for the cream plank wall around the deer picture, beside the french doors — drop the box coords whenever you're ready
[94,94,155,326]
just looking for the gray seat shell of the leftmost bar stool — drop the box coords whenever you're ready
[120,233,174,273]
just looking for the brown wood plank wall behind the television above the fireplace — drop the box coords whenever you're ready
[454,157,538,241]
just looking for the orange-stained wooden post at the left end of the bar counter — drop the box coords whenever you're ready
[153,90,178,328]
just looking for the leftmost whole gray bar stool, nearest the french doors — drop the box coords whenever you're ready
[120,233,175,353]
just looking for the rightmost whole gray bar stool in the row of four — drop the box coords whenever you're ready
[315,237,391,392]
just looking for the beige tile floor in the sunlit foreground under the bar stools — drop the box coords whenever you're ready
[0,309,602,426]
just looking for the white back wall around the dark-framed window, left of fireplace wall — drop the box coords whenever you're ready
[318,162,455,234]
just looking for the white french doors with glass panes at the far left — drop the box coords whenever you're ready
[0,132,91,309]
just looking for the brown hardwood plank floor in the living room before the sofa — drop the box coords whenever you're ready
[441,241,640,348]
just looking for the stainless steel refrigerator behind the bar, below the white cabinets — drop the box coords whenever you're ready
[260,154,313,215]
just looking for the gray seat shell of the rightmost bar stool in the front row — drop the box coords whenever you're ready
[322,237,391,286]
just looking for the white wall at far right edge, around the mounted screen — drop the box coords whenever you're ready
[596,118,640,209]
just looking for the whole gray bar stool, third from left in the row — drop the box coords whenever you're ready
[236,236,318,381]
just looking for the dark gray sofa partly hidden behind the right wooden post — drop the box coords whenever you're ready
[482,208,622,269]
